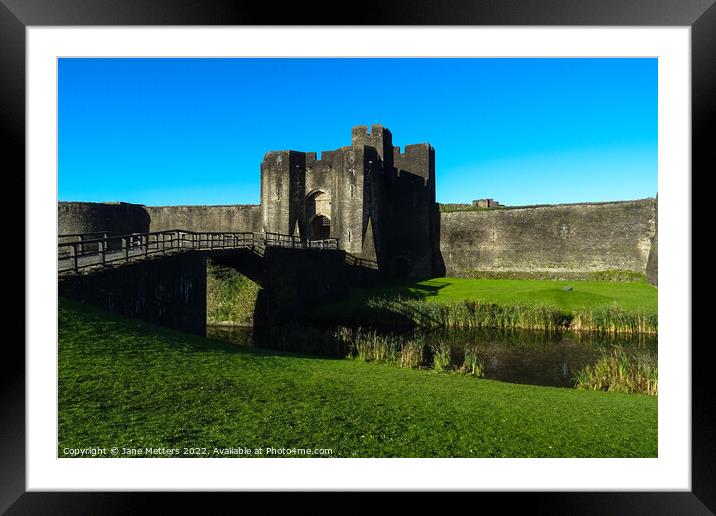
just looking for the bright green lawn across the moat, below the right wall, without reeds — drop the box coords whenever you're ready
[321,278,658,314]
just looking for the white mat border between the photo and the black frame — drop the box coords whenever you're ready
[26,27,691,491]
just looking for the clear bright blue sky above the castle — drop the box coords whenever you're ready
[58,58,658,205]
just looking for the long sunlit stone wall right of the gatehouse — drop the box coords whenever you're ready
[440,198,656,276]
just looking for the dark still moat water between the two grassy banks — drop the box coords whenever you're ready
[207,326,658,387]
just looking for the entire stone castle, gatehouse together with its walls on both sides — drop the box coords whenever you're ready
[58,125,658,283]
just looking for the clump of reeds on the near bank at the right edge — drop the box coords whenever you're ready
[574,346,659,396]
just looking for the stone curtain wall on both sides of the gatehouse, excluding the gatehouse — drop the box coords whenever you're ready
[58,198,658,284]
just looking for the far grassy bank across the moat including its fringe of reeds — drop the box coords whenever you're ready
[312,278,658,333]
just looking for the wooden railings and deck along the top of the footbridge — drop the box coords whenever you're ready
[57,229,342,274]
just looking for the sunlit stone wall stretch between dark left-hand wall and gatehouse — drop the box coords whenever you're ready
[144,204,261,232]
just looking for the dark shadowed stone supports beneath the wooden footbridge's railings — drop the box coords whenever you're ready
[58,247,356,335]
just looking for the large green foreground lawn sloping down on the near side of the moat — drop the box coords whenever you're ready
[58,296,657,457]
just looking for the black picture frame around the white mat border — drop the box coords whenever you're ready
[0,0,716,514]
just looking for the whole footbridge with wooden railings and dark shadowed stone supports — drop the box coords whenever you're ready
[57,229,382,335]
